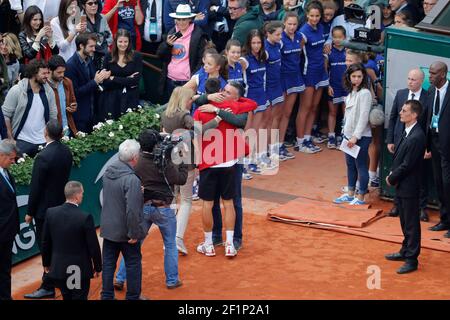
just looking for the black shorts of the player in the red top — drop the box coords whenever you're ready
[198,165,236,201]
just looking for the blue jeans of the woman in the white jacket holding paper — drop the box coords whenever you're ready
[345,137,372,194]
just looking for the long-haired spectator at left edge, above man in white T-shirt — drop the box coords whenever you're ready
[0,32,22,88]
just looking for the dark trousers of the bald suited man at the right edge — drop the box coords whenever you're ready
[431,134,450,225]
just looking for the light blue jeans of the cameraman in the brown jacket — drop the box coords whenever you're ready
[116,205,178,285]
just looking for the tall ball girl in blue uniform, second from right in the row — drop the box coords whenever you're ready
[295,1,328,153]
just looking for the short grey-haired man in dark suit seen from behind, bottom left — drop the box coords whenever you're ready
[42,181,102,300]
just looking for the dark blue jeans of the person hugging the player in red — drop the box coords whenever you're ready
[212,163,244,241]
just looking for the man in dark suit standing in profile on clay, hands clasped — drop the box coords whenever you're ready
[385,100,426,274]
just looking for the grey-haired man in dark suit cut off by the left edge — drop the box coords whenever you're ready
[0,140,19,300]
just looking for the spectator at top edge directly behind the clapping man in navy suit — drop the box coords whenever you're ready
[81,0,113,70]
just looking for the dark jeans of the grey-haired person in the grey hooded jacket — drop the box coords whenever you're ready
[101,239,142,300]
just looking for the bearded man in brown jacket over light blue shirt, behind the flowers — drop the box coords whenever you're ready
[48,55,78,136]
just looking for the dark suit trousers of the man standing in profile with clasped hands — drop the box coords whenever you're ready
[398,197,420,264]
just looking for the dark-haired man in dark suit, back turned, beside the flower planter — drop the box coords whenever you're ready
[25,120,72,299]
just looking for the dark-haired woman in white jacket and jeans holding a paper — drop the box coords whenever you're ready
[333,63,372,205]
